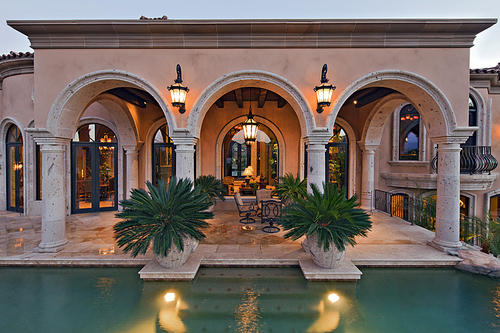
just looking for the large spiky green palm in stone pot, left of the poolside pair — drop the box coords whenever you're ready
[113,177,213,268]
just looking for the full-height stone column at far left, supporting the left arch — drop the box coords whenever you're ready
[34,138,70,252]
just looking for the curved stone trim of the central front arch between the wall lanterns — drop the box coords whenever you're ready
[186,70,316,138]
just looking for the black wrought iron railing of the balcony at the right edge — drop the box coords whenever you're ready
[431,146,498,175]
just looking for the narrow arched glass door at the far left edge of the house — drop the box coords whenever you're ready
[5,125,24,213]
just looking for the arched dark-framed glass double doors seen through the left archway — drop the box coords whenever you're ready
[71,123,118,213]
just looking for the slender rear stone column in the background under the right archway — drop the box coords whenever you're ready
[358,142,378,212]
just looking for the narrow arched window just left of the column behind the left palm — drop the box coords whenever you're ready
[153,124,175,185]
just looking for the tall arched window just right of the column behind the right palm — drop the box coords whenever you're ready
[325,123,349,189]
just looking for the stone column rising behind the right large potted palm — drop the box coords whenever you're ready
[305,131,331,192]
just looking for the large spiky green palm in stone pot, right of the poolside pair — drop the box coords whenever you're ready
[279,184,372,268]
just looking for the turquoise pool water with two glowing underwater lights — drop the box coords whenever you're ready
[0,267,500,333]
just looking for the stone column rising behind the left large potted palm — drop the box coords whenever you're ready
[171,132,197,182]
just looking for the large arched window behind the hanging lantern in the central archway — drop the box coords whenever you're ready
[222,124,279,194]
